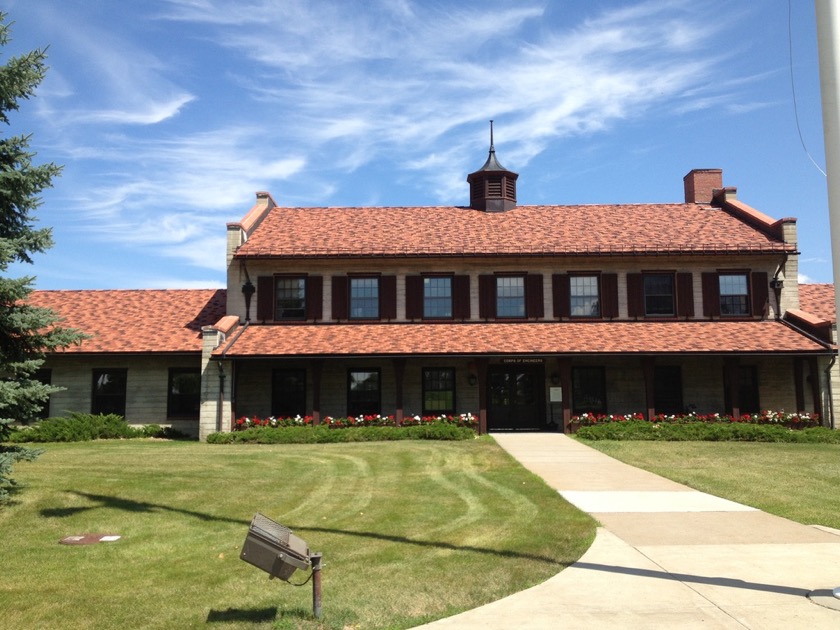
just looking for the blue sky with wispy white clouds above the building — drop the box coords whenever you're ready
[0,0,833,289]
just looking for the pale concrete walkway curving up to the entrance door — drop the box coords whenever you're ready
[421,433,840,630]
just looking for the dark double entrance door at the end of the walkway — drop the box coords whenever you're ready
[487,365,545,431]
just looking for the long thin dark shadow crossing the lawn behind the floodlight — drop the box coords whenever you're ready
[41,490,570,568]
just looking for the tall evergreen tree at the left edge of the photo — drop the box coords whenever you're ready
[0,12,84,501]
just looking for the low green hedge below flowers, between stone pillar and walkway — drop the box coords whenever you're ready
[207,423,476,444]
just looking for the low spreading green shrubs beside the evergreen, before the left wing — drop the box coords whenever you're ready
[8,412,185,443]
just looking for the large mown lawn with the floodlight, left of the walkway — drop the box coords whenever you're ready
[0,438,594,630]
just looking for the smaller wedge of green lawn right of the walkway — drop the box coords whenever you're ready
[581,440,840,529]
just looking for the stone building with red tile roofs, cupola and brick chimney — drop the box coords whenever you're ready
[26,143,837,437]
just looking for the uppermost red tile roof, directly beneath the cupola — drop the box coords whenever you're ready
[236,203,795,258]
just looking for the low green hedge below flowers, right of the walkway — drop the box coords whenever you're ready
[576,420,840,444]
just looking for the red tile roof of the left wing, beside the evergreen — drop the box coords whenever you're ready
[28,289,226,353]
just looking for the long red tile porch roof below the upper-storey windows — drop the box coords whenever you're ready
[214,321,827,357]
